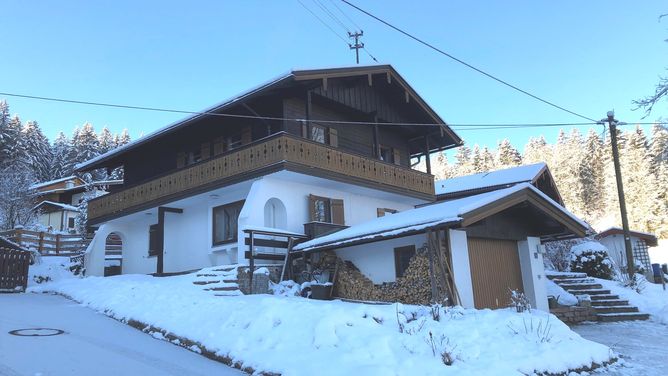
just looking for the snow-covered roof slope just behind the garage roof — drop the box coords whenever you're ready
[435,162,547,195]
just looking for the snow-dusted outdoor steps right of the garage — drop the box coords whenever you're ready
[547,273,649,322]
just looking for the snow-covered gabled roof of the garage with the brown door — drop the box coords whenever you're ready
[294,183,587,251]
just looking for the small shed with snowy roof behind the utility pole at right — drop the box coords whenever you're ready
[596,227,659,276]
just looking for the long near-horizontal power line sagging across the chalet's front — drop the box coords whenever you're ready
[0,92,668,130]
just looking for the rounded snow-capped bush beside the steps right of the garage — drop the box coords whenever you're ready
[570,242,615,279]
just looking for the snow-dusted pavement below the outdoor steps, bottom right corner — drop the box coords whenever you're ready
[573,321,668,376]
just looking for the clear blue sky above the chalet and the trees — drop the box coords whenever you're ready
[0,0,668,147]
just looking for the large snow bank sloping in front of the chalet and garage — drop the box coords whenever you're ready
[30,275,611,376]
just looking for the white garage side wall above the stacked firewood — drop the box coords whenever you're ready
[336,234,427,284]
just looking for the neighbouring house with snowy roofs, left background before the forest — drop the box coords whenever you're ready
[30,176,121,232]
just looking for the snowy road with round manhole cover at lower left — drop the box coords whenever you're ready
[0,294,243,376]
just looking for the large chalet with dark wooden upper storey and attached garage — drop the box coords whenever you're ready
[77,65,584,307]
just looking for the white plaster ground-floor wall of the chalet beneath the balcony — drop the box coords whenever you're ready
[87,171,424,275]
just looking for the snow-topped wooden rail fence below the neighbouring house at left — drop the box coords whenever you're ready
[0,229,90,255]
